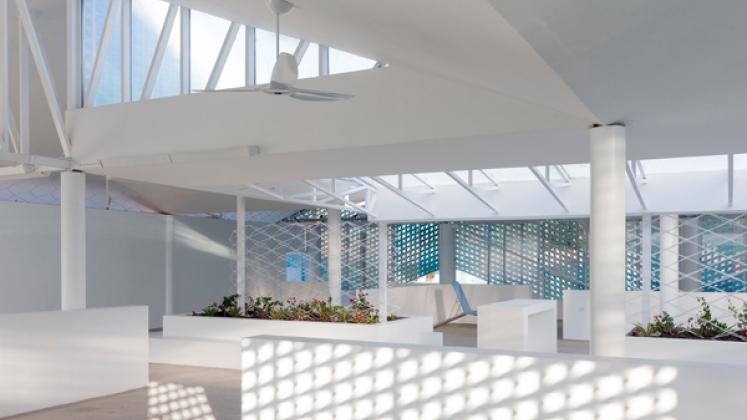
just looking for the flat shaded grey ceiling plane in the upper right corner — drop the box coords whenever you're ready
[490,0,747,157]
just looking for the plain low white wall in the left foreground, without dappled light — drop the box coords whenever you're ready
[0,306,148,417]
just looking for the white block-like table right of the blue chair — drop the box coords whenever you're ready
[477,299,558,353]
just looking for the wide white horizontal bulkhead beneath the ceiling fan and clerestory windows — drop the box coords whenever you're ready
[69,68,588,187]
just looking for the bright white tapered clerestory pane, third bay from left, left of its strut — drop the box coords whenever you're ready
[190,10,231,89]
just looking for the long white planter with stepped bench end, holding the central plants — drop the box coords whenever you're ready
[155,315,443,369]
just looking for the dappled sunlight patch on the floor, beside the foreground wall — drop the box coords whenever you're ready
[148,382,216,420]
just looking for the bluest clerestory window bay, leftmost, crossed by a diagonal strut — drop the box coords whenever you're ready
[81,0,122,106]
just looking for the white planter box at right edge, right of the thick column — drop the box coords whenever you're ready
[625,337,747,366]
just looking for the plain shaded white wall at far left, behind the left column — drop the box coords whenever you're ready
[0,202,234,328]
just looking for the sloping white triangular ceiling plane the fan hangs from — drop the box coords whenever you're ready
[175,0,597,122]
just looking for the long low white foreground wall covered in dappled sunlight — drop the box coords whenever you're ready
[242,337,747,420]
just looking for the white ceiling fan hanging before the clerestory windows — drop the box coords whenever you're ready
[206,0,353,102]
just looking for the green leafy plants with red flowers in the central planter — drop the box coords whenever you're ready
[193,291,398,324]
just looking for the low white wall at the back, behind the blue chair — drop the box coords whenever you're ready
[380,284,532,324]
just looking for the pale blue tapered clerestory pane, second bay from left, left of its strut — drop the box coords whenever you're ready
[131,0,169,101]
